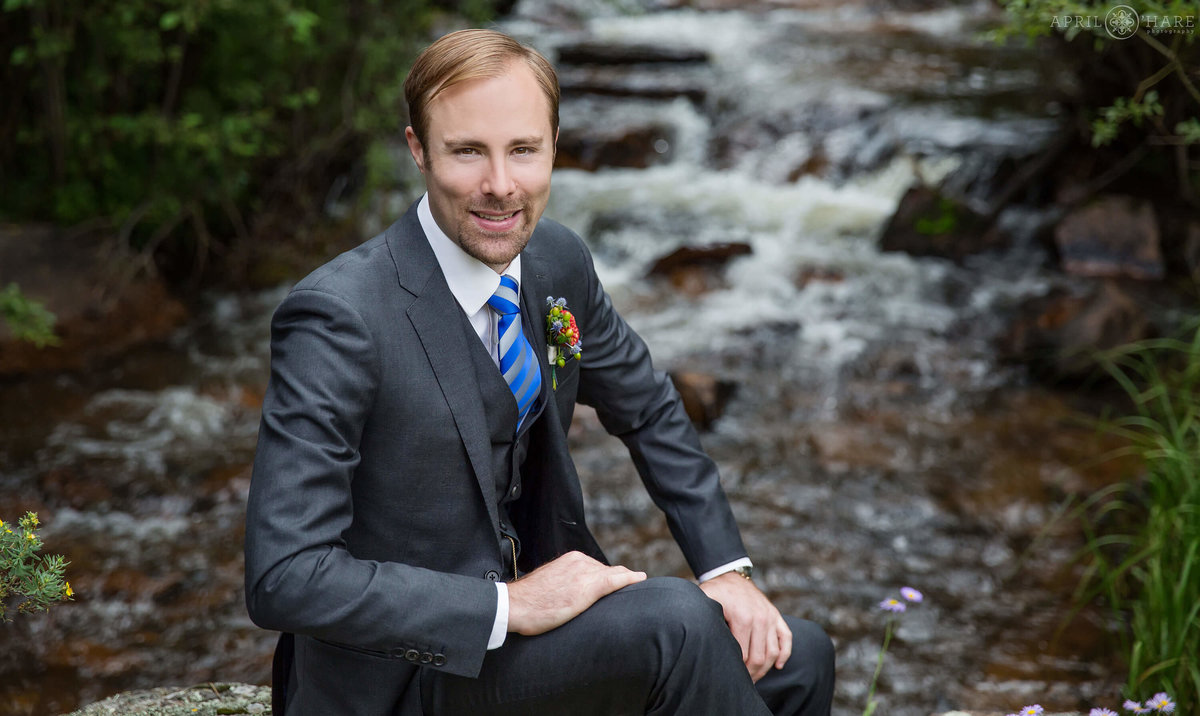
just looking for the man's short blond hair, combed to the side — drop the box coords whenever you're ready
[404,30,559,145]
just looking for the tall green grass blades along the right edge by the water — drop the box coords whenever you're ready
[1079,327,1200,710]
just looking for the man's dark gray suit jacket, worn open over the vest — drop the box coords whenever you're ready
[246,205,745,715]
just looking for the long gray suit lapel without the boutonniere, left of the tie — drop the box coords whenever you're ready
[388,204,500,542]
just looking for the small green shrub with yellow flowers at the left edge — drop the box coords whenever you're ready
[0,512,74,621]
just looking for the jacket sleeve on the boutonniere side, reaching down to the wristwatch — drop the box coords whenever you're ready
[576,239,746,576]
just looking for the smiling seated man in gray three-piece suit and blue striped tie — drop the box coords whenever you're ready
[246,30,833,716]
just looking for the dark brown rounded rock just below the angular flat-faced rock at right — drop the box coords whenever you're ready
[997,281,1154,379]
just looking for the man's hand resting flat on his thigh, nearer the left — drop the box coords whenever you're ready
[509,552,648,636]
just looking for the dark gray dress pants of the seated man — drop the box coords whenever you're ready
[420,577,834,716]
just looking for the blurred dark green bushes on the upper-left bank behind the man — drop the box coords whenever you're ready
[0,0,493,268]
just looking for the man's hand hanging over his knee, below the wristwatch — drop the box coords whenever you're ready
[700,572,792,681]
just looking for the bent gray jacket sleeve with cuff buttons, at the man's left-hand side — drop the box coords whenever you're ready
[246,289,497,676]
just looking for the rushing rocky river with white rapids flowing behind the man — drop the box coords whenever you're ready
[0,0,1121,716]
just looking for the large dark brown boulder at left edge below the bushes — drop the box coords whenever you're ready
[0,224,187,378]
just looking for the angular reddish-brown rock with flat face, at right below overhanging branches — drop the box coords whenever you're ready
[1054,195,1166,281]
